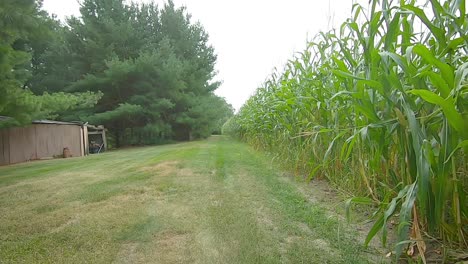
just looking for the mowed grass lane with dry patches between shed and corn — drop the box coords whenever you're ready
[0,137,380,263]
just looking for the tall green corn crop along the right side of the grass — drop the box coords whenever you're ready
[224,0,468,259]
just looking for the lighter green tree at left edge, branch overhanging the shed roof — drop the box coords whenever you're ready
[0,0,101,127]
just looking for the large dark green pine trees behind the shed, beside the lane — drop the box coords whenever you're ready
[26,0,233,146]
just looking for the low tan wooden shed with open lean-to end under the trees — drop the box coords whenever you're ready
[0,120,107,165]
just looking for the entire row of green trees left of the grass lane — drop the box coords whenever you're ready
[0,0,233,147]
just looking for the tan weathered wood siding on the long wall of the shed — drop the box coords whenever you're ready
[0,124,83,165]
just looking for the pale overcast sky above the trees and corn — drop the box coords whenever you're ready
[44,0,354,110]
